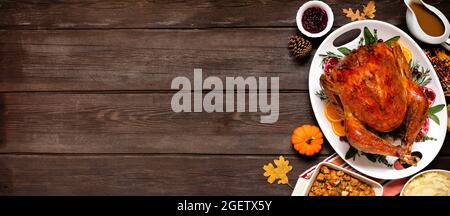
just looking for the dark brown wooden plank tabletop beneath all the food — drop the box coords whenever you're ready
[0,0,450,195]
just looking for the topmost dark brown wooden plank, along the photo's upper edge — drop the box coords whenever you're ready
[0,0,450,29]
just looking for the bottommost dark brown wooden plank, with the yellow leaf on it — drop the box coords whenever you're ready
[0,155,450,196]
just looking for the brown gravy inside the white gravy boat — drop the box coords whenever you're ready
[409,3,445,37]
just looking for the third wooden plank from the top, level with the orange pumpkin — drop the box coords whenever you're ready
[0,93,332,154]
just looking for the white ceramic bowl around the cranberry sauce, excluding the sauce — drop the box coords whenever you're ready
[296,1,334,38]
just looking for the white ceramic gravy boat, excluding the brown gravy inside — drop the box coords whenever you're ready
[404,0,450,51]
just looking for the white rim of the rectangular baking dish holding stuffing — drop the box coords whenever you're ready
[301,162,383,196]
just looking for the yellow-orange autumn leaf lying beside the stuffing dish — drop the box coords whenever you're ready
[263,156,292,184]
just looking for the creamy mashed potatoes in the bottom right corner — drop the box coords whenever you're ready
[403,171,450,196]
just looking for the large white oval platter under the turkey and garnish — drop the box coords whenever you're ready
[309,20,447,179]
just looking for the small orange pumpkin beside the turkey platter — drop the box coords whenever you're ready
[291,125,323,156]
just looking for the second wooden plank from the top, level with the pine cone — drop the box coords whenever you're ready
[0,29,312,91]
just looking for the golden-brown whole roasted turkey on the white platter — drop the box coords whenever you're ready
[320,42,428,165]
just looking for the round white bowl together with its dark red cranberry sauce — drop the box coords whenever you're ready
[296,1,334,38]
